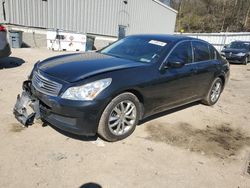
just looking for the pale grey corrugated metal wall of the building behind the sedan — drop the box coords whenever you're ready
[2,0,176,36]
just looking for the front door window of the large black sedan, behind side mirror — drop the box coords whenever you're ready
[168,41,192,63]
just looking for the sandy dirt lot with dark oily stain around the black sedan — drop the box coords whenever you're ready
[0,48,250,188]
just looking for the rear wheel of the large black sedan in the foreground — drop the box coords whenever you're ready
[201,77,223,106]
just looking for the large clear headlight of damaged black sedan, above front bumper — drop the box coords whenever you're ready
[62,78,112,101]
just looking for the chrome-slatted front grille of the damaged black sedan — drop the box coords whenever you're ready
[32,71,62,96]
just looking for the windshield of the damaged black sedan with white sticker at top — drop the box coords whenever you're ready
[100,37,167,63]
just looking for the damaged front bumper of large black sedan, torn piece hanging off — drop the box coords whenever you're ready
[13,80,108,136]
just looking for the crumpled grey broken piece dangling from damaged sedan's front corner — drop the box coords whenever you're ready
[13,81,40,127]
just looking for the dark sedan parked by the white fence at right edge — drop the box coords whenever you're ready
[221,41,250,65]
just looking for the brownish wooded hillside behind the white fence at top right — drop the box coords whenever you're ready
[171,0,250,32]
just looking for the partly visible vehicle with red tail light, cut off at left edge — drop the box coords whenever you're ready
[0,24,11,58]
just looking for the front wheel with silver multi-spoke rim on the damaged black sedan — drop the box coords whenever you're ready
[97,92,140,142]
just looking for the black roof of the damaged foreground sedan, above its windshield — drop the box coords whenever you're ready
[128,34,198,42]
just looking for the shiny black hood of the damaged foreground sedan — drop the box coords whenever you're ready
[37,52,145,82]
